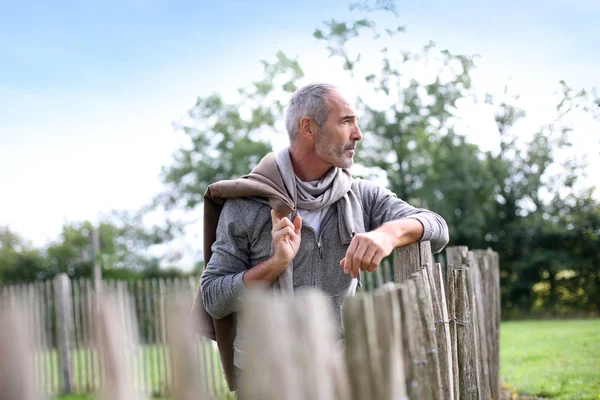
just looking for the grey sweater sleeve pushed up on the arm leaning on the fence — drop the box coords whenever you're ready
[359,180,449,253]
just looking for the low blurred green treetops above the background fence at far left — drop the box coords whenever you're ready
[0,211,185,284]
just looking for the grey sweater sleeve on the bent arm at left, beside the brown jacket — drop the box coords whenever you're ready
[200,199,250,319]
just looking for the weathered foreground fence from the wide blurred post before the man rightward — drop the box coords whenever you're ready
[241,243,500,400]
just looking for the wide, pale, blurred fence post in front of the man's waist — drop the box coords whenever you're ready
[240,290,350,400]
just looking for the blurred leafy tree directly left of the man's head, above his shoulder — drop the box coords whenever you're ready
[155,52,303,210]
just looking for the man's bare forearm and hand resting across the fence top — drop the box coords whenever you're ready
[340,218,423,278]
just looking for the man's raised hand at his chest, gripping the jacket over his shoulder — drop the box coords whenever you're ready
[271,210,302,266]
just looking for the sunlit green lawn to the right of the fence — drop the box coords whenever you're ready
[500,319,600,400]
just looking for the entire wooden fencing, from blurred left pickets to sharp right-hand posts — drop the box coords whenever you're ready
[0,242,500,400]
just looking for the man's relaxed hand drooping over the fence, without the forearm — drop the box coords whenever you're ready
[340,230,395,278]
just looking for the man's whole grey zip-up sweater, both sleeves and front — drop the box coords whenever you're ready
[200,179,448,366]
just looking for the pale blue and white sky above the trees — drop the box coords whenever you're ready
[0,0,600,266]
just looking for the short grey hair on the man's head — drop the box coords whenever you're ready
[285,83,337,142]
